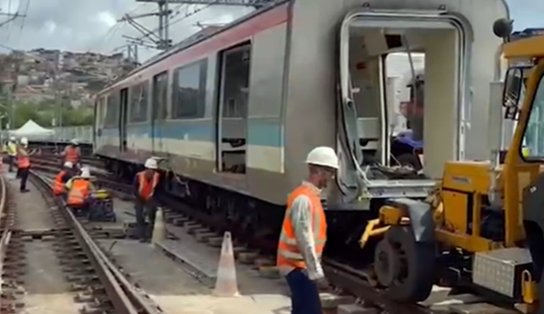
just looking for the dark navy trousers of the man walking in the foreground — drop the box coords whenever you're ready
[285,269,323,314]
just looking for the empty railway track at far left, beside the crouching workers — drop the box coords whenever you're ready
[0,166,161,314]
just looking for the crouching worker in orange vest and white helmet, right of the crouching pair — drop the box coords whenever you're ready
[66,167,95,216]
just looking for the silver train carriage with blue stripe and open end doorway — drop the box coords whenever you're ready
[50,0,509,254]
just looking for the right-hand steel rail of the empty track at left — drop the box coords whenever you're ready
[30,170,160,314]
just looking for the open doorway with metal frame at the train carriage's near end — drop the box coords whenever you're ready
[337,8,471,203]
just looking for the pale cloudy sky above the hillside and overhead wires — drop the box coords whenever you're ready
[0,0,544,61]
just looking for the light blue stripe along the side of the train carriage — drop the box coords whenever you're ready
[102,119,283,147]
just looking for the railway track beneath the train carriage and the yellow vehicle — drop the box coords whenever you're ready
[28,151,512,314]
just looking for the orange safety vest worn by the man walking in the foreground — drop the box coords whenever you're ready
[277,185,327,269]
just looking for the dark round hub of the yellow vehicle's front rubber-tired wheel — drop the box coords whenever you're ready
[374,239,400,287]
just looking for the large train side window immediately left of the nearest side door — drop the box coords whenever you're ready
[172,59,208,119]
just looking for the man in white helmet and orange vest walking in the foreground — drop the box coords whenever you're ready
[277,146,338,314]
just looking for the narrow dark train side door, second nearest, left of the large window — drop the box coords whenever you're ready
[151,71,168,153]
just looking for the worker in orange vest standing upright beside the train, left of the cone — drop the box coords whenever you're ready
[134,158,160,242]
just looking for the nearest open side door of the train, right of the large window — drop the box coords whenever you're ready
[216,42,251,175]
